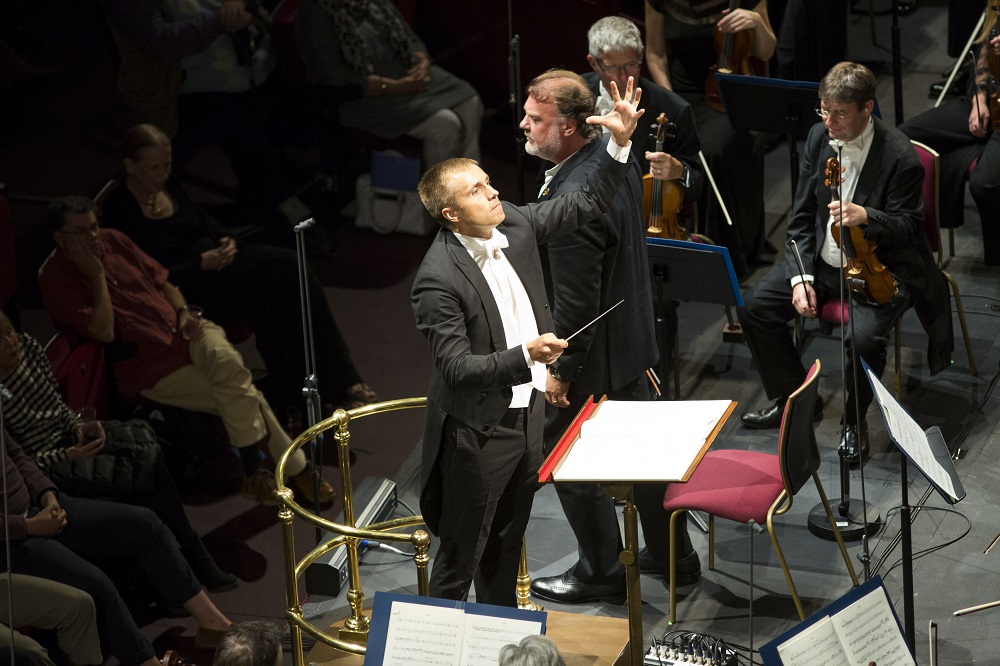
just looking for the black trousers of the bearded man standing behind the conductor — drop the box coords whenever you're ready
[545,375,691,583]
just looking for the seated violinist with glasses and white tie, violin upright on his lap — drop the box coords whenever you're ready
[737,62,953,463]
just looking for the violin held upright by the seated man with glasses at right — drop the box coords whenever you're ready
[823,157,897,305]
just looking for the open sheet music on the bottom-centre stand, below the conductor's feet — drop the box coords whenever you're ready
[382,601,542,666]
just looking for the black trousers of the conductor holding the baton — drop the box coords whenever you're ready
[430,392,543,606]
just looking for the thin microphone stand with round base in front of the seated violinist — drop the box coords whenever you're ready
[809,141,882,548]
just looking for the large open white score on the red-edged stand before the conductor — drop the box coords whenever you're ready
[553,400,732,481]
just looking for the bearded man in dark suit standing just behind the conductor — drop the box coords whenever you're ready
[521,70,700,603]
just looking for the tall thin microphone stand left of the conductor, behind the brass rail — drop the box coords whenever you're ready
[294,217,323,545]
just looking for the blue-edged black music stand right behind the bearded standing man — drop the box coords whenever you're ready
[646,238,743,400]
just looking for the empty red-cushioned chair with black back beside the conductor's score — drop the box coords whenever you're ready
[663,360,858,623]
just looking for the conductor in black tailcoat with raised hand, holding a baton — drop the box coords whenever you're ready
[411,79,642,606]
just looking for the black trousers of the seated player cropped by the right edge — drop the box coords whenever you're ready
[899,97,1000,266]
